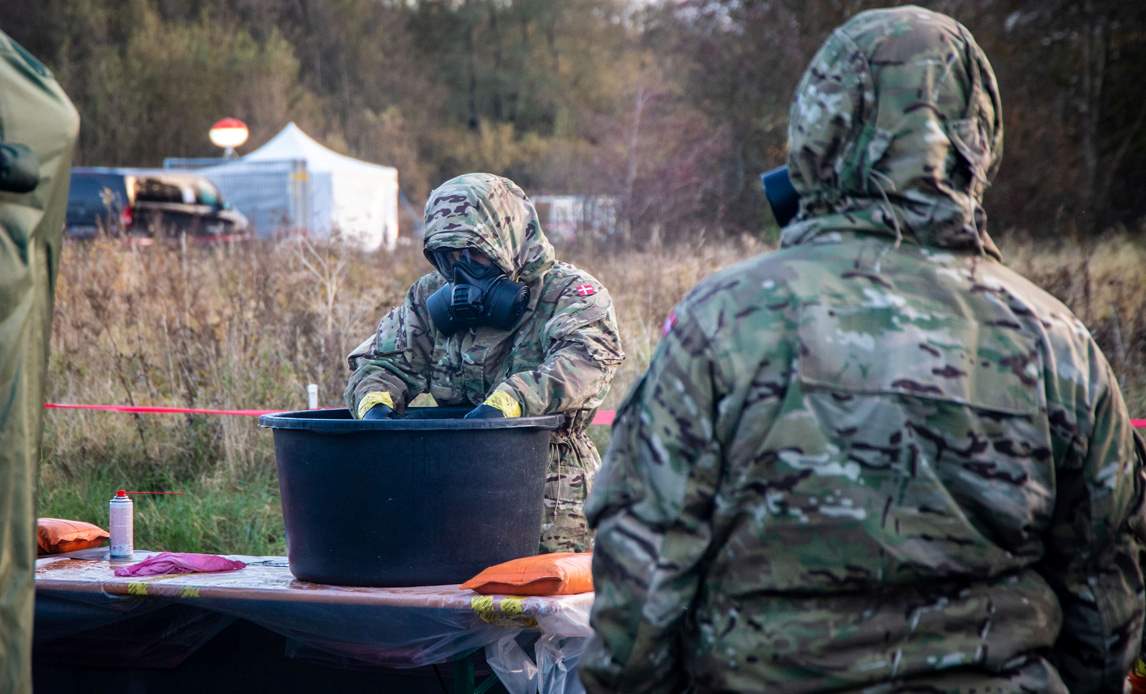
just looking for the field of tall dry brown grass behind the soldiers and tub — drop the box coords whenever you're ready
[41,235,1146,550]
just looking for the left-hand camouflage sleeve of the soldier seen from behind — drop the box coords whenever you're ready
[581,300,786,692]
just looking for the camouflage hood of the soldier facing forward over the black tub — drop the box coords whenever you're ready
[423,173,554,284]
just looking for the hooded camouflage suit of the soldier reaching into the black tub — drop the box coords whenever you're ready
[346,173,623,552]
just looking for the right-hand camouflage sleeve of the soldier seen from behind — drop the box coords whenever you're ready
[1041,346,1146,692]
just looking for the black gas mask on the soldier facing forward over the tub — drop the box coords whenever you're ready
[426,249,529,334]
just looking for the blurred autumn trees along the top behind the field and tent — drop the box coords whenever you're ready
[0,0,1146,240]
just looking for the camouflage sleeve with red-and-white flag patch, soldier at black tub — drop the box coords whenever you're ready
[494,282,623,417]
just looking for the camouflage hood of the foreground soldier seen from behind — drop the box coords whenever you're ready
[783,7,1003,258]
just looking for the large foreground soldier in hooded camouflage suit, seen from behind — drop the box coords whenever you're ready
[581,7,1143,692]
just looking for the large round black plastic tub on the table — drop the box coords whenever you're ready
[259,408,562,586]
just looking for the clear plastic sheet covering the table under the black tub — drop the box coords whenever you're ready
[36,549,592,694]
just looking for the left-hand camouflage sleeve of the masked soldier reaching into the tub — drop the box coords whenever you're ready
[346,275,441,417]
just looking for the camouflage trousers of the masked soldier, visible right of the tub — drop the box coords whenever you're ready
[541,432,601,552]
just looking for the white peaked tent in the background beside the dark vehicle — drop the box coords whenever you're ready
[198,123,398,251]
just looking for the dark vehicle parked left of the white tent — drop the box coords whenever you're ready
[68,168,250,240]
